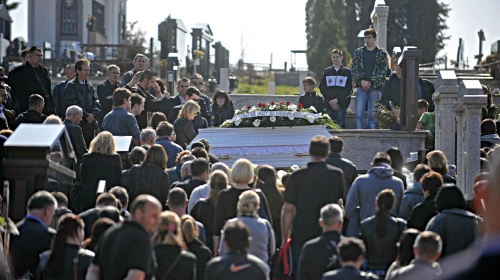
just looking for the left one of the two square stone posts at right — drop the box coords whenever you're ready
[432,70,458,164]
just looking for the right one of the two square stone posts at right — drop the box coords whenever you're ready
[452,80,487,199]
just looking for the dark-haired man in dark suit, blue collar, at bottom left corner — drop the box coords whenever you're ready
[10,191,57,279]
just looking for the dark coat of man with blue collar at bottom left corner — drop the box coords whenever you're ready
[10,218,56,276]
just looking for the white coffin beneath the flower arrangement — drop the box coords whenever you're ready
[188,125,331,168]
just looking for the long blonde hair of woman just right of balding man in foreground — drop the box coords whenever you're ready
[153,211,186,250]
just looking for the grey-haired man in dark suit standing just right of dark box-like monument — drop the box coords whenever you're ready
[64,105,87,178]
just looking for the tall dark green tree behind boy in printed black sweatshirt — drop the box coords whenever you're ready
[306,0,352,78]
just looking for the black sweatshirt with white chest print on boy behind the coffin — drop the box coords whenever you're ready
[319,65,352,109]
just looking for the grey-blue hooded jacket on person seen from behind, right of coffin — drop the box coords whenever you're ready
[345,163,404,221]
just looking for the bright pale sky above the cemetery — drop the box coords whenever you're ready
[7,0,500,68]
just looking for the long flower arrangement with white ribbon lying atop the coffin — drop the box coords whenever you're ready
[220,101,340,130]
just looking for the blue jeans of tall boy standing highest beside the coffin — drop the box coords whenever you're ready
[356,88,380,129]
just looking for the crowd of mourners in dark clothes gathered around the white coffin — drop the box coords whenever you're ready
[0,26,500,280]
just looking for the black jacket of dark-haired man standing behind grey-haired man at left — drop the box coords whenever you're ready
[64,77,101,120]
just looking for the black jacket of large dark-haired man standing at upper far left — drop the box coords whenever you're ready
[9,61,55,115]
